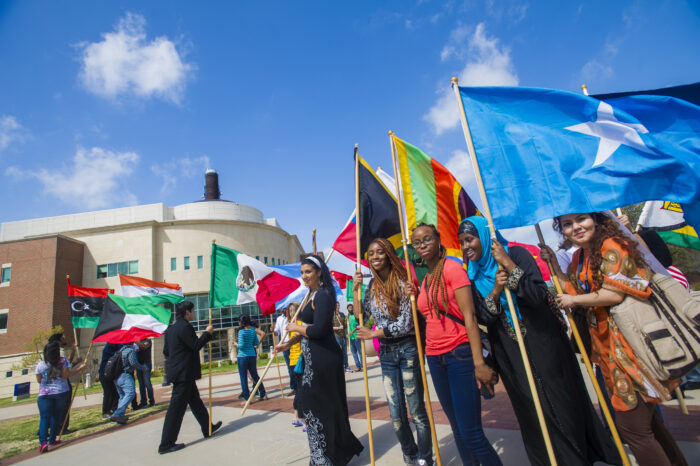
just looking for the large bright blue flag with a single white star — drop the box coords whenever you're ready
[459,87,700,228]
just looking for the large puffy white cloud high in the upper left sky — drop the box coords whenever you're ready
[80,13,194,104]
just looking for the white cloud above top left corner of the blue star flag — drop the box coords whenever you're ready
[423,23,520,135]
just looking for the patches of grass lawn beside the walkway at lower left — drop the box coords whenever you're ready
[0,403,168,460]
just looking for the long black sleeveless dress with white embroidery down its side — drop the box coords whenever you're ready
[297,289,363,466]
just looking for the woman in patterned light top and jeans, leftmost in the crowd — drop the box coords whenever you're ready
[34,341,85,453]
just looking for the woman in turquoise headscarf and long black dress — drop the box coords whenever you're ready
[458,217,621,466]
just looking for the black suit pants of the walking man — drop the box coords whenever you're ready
[158,380,209,451]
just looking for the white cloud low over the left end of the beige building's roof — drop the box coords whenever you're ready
[13,147,139,209]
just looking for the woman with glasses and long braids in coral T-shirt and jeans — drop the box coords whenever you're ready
[411,223,501,465]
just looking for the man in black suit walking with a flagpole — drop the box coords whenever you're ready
[158,301,221,454]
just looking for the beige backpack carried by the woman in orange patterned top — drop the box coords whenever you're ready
[610,274,700,381]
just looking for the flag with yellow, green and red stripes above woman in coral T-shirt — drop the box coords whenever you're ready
[394,136,478,262]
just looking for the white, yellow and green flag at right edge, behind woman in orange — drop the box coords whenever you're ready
[638,201,700,249]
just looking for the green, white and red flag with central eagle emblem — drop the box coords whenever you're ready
[209,243,299,315]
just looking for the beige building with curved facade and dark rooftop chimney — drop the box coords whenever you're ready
[0,170,304,396]
